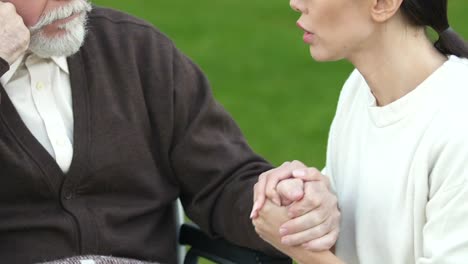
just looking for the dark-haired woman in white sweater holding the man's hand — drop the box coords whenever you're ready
[254,0,468,264]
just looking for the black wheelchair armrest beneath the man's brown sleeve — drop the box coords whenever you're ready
[179,224,292,264]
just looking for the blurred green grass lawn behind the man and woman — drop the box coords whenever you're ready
[89,0,468,262]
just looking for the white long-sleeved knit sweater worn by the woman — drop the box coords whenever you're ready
[325,56,468,264]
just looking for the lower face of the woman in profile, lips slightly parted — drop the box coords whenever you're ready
[290,0,374,61]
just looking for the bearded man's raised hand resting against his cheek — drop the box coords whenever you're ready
[0,1,30,65]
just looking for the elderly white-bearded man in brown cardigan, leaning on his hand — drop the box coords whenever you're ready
[0,0,337,263]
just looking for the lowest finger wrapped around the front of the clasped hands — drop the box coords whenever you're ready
[281,218,332,246]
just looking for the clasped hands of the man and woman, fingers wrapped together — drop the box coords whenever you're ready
[251,161,340,253]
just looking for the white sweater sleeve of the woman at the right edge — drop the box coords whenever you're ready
[417,130,468,264]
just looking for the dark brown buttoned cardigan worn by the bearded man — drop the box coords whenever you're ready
[0,7,280,263]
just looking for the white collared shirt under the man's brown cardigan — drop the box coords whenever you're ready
[0,54,73,172]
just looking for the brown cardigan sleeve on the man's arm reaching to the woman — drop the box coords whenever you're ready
[170,43,286,254]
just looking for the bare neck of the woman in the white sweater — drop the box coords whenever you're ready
[348,25,447,106]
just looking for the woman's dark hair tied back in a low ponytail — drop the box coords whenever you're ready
[400,0,468,58]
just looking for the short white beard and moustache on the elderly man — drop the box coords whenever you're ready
[29,0,91,58]
